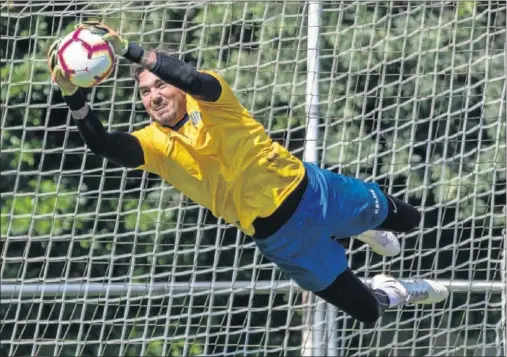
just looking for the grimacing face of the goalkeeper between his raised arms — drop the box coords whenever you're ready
[139,70,187,126]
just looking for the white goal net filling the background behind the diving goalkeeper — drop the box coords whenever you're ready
[0,0,507,356]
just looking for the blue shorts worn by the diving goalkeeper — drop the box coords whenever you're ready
[254,163,388,292]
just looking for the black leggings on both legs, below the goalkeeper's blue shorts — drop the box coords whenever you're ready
[315,195,421,323]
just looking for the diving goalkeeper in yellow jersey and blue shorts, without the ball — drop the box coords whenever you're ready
[48,22,449,323]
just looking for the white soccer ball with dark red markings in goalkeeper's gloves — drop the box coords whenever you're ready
[57,28,114,88]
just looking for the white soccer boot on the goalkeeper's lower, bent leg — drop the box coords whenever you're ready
[371,274,449,307]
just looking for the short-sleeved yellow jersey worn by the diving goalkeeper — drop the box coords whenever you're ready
[132,71,305,235]
